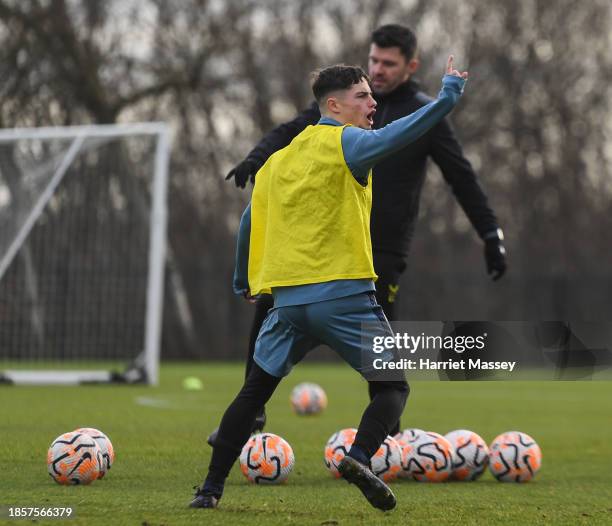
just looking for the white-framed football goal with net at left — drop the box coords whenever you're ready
[0,123,169,384]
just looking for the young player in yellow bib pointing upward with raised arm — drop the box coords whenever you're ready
[190,56,467,510]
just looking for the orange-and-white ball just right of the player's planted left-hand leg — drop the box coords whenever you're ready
[240,433,295,484]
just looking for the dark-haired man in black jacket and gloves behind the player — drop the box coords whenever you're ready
[216,24,506,446]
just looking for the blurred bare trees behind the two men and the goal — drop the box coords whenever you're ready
[0,0,612,364]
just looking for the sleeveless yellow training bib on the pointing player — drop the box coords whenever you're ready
[249,125,377,295]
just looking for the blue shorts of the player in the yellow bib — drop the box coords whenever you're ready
[254,292,394,379]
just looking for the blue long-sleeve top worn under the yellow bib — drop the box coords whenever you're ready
[233,75,465,307]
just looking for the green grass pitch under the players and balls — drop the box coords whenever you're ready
[0,363,612,526]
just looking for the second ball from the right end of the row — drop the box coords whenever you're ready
[445,429,489,480]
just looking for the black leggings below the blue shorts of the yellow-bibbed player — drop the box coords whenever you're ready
[207,363,409,484]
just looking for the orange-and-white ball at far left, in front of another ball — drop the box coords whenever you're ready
[47,431,102,486]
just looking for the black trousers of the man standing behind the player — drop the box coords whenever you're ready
[245,252,406,435]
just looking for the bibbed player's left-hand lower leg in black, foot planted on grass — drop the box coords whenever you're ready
[189,364,281,508]
